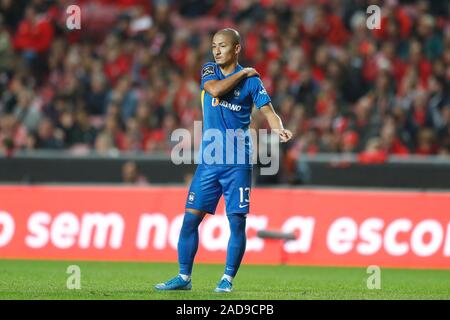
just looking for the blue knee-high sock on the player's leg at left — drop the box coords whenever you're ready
[178,212,203,275]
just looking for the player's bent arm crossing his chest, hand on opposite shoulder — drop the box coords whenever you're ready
[202,64,259,98]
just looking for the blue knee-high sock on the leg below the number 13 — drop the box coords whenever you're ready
[225,214,247,277]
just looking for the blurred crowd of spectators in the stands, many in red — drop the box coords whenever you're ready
[0,0,450,182]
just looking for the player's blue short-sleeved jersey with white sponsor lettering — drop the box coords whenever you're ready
[200,62,270,167]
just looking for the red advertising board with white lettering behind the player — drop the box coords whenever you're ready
[0,186,450,269]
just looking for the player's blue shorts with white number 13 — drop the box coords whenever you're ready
[186,165,252,214]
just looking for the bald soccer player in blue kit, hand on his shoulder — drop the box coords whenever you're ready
[155,28,292,292]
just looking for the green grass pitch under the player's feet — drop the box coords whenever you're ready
[0,260,450,300]
